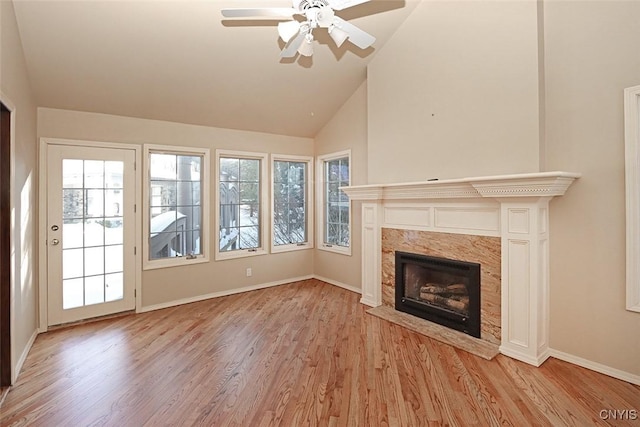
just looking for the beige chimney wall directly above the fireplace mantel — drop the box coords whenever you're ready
[368,0,540,184]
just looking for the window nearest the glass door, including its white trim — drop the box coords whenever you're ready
[144,145,209,268]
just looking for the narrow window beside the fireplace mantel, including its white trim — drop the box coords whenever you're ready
[318,151,351,255]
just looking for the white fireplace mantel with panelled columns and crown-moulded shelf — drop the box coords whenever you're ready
[342,172,580,366]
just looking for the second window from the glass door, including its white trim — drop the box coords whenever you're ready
[216,150,267,259]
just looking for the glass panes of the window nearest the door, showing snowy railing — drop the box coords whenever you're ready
[149,153,202,259]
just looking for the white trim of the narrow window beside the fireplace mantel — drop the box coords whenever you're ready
[316,150,353,256]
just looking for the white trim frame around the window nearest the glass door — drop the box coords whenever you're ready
[142,144,211,270]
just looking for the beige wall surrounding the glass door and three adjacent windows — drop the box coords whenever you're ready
[38,108,313,307]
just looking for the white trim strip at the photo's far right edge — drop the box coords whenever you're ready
[624,86,640,312]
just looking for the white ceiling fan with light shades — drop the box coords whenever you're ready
[222,0,376,58]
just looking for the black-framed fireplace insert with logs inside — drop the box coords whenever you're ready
[395,251,480,338]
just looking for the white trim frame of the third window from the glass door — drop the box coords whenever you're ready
[269,154,314,253]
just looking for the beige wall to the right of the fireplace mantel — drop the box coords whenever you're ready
[544,1,640,375]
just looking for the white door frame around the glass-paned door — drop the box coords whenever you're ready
[38,138,143,332]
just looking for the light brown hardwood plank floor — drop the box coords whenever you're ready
[0,280,640,427]
